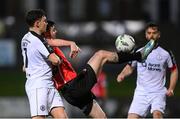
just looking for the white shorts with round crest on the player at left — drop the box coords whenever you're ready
[26,88,64,117]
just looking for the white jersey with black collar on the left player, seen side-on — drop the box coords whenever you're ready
[21,31,54,89]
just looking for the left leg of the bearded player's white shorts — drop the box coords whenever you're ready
[128,93,150,117]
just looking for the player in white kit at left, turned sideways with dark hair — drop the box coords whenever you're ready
[21,9,67,119]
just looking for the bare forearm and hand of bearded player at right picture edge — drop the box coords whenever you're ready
[166,66,178,96]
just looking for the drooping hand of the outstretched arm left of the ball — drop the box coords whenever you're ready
[69,42,81,58]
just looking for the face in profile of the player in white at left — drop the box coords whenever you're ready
[37,16,47,33]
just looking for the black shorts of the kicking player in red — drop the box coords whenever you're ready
[61,64,97,115]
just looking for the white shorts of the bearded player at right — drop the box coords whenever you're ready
[128,92,166,117]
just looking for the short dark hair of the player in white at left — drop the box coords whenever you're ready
[26,9,46,27]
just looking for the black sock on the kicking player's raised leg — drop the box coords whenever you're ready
[117,52,141,64]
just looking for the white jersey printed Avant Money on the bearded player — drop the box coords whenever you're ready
[131,46,175,93]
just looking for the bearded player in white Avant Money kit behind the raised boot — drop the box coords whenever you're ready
[117,23,178,118]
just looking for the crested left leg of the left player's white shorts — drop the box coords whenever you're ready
[26,88,48,117]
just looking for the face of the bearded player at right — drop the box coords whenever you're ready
[146,27,160,40]
